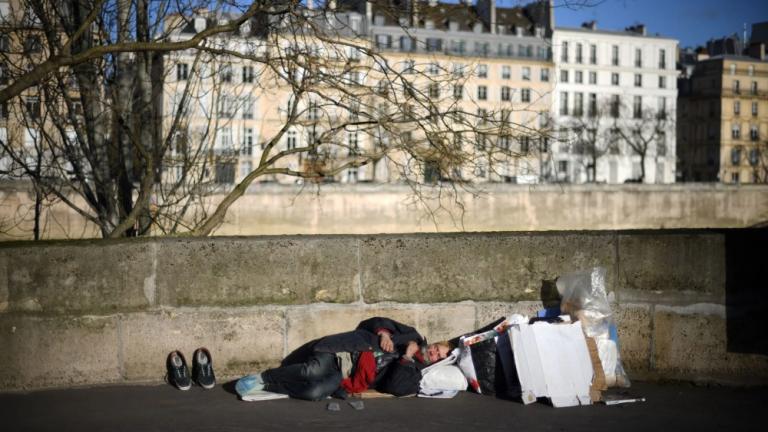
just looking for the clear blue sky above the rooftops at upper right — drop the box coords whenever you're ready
[497,0,768,47]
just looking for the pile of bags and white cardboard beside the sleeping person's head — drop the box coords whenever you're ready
[419,267,630,407]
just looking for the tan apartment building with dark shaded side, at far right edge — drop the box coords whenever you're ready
[677,54,768,184]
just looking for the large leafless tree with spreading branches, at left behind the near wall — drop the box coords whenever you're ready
[0,0,552,237]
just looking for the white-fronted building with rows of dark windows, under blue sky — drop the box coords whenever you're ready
[552,23,677,183]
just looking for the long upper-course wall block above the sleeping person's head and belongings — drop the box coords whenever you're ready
[360,233,615,303]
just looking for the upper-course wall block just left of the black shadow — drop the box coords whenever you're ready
[618,232,725,303]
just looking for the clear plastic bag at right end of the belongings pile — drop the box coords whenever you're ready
[557,267,630,387]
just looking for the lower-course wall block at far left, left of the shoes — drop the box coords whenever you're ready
[0,314,121,390]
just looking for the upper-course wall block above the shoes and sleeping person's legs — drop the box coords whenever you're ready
[157,237,359,306]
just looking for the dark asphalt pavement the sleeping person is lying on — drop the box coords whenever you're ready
[0,383,768,432]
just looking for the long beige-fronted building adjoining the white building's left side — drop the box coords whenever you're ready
[164,1,554,184]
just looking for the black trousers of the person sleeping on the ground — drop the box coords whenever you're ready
[261,353,342,401]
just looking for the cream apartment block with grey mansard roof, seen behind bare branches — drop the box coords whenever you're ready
[164,0,554,183]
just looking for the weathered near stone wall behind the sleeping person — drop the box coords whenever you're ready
[0,230,768,390]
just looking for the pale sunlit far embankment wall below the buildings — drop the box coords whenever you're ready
[0,183,768,241]
